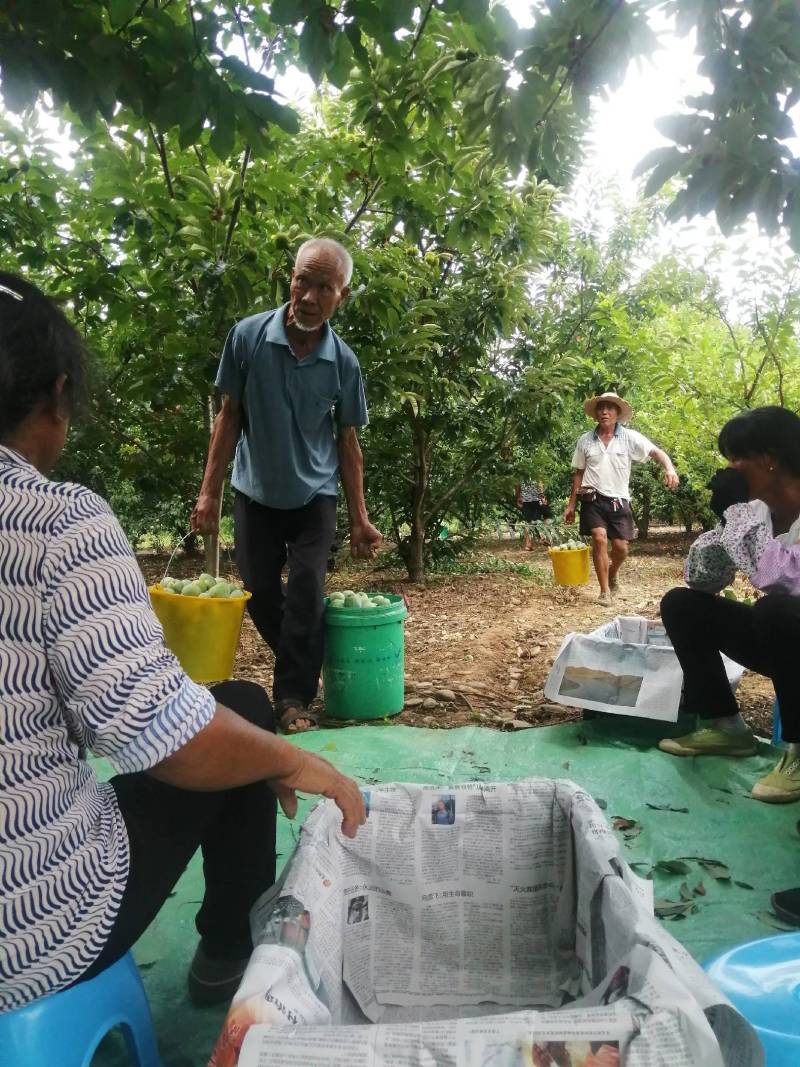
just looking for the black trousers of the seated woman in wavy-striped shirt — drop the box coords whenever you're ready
[78,682,276,982]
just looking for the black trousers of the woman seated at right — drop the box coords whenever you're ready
[661,588,800,742]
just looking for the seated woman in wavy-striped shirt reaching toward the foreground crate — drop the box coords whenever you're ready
[0,273,366,1012]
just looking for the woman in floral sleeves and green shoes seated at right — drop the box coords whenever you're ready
[658,408,800,803]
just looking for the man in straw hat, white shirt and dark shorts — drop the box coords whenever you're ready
[564,393,678,604]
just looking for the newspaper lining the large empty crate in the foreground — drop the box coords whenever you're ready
[211,778,764,1067]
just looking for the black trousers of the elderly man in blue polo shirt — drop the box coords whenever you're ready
[234,493,336,704]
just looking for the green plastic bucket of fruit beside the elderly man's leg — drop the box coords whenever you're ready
[322,593,409,719]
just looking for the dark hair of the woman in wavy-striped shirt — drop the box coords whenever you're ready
[0,271,86,441]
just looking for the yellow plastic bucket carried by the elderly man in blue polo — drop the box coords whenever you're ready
[147,586,252,683]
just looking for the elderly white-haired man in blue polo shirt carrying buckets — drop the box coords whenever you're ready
[192,238,382,733]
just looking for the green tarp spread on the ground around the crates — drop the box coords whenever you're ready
[98,716,800,1067]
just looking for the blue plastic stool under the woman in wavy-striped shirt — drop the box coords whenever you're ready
[0,953,161,1067]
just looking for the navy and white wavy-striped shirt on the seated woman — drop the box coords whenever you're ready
[0,446,214,1012]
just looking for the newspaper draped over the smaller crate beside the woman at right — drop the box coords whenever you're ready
[544,616,745,722]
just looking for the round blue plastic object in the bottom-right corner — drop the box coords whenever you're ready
[703,933,800,1067]
